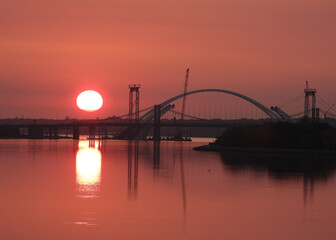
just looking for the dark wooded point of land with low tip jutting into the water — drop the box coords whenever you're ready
[194,120,336,156]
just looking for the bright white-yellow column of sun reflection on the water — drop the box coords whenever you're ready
[76,141,101,198]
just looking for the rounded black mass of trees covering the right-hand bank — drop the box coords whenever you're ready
[214,121,336,150]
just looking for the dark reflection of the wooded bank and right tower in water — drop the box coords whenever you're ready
[221,152,336,206]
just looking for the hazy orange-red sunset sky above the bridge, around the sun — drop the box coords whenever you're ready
[0,0,336,119]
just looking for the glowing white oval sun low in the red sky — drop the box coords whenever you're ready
[76,90,103,112]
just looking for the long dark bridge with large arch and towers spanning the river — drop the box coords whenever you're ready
[0,85,336,140]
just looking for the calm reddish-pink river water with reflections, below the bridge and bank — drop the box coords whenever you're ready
[0,140,336,240]
